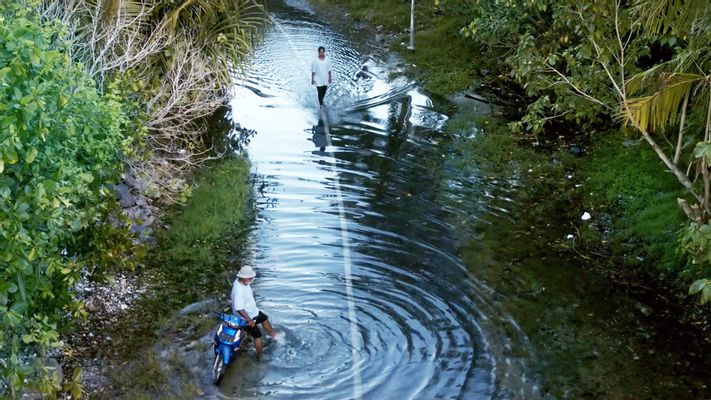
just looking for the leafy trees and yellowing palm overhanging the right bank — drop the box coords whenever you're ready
[450,0,711,303]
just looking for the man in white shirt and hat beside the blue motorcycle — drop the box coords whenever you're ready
[232,265,275,358]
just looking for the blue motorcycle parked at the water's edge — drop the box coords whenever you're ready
[212,313,249,385]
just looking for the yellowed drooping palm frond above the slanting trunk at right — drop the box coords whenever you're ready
[620,73,706,132]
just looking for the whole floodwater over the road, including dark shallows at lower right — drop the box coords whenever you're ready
[174,1,708,399]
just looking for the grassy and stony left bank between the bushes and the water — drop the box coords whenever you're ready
[63,155,253,398]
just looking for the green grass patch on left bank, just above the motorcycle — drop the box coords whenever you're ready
[152,158,252,302]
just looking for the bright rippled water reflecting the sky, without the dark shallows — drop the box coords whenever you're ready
[211,2,537,399]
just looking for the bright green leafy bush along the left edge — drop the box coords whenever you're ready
[0,3,134,395]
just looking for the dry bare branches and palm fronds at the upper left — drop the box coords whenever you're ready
[42,0,267,201]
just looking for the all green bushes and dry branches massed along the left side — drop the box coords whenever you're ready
[0,0,264,397]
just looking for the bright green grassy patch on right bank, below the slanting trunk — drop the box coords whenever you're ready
[583,132,685,272]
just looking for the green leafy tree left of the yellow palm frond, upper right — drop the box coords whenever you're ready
[462,0,648,134]
